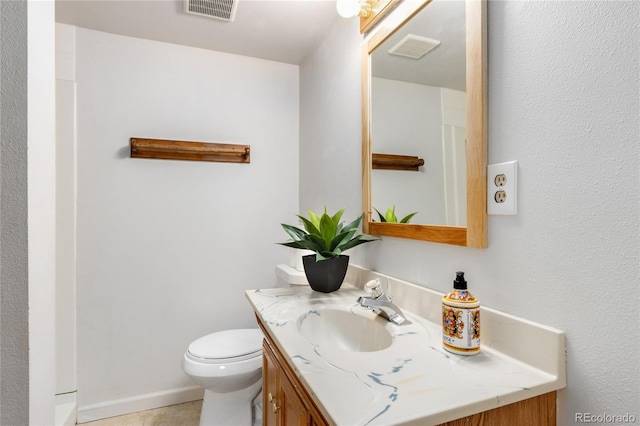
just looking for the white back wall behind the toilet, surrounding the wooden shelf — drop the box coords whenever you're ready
[76,28,299,421]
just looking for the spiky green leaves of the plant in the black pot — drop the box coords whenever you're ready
[278,207,378,262]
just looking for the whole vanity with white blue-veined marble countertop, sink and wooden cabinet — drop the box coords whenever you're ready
[246,265,566,426]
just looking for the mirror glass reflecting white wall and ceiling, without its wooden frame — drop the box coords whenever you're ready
[370,1,467,226]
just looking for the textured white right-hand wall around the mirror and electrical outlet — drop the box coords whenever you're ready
[300,1,640,425]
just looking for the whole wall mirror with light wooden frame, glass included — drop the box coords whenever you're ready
[363,0,486,247]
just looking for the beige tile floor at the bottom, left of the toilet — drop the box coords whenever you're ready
[82,400,202,426]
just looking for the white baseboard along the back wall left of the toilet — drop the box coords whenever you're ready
[78,386,204,423]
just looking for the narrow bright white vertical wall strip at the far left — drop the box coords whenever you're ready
[27,1,56,425]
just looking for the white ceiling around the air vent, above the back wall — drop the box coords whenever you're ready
[56,0,343,65]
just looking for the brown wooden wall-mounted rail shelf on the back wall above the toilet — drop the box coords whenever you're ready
[131,138,251,163]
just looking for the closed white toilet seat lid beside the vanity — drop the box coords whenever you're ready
[189,328,264,359]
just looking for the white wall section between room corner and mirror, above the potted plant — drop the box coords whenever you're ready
[299,19,362,225]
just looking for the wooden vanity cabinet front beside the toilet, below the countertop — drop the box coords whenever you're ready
[258,330,328,426]
